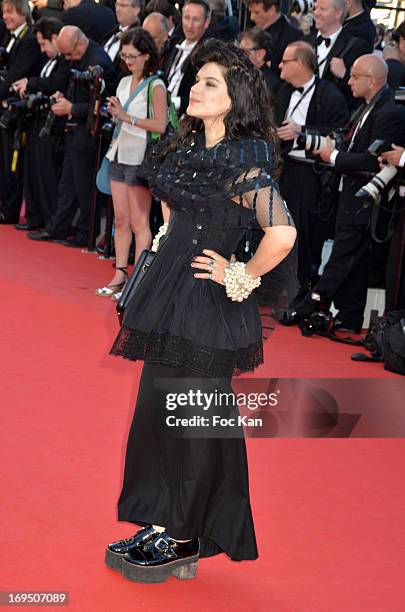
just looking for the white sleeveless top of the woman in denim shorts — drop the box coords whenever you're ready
[106,75,166,166]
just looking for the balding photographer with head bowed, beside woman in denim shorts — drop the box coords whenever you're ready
[27,26,115,247]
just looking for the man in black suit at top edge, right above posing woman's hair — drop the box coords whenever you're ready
[247,0,302,79]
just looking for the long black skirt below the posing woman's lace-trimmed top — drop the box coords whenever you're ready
[118,363,258,561]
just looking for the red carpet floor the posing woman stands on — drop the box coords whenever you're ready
[0,227,405,612]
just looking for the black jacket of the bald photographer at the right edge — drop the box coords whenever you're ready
[335,87,404,224]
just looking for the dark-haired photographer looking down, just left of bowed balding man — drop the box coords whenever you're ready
[13,17,70,230]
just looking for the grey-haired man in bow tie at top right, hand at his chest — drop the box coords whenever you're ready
[306,0,369,108]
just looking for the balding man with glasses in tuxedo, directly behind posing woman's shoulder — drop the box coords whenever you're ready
[276,41,349,307]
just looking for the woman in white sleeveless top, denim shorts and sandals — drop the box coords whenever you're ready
[96,28,167,300]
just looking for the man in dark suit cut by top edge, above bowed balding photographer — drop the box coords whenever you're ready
[60,0,116,43]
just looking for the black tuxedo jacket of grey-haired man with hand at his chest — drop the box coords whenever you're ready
[305,28,369,108]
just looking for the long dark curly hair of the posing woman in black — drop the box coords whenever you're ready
[161,38,278,163]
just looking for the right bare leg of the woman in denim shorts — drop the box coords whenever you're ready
[128,185,152,262]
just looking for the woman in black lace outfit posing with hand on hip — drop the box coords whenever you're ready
[106,39,296,582]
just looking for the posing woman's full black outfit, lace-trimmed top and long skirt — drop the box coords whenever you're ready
[111,134,296,560]
